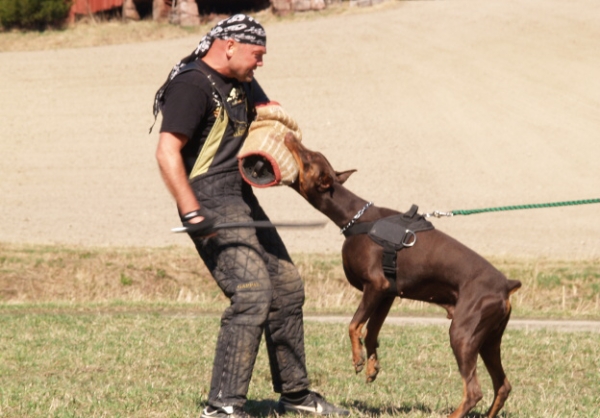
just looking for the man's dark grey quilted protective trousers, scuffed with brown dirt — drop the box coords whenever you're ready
[192,171,309,407]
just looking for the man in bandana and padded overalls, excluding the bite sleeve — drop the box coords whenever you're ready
[154,14,349,418]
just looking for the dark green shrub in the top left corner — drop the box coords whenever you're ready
[0,0,73,30]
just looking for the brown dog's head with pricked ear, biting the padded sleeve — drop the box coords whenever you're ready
[284,133,356,203]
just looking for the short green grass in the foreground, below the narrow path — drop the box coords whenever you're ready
[0,309,600,418]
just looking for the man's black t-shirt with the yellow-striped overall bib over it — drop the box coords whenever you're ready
[160,60,268,175]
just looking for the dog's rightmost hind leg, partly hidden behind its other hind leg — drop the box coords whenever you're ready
[479,308,511,418]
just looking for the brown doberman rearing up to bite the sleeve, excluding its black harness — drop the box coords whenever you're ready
[285,135,521,418]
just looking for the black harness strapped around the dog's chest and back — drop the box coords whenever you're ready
[343,205,434,289]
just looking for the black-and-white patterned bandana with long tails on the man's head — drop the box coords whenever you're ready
[150,14,267,132]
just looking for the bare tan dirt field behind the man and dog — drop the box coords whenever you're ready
[0,0,600,258]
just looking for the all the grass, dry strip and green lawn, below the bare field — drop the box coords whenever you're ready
[0,244,600,418]
